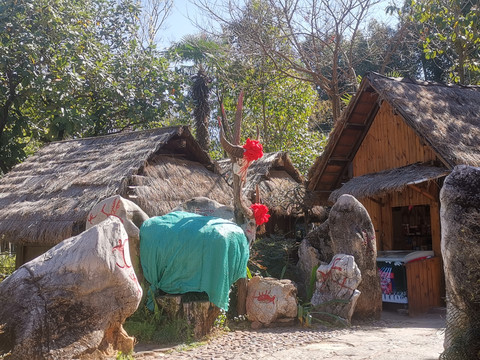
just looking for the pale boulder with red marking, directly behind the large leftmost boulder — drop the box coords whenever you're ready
[86,195,148,283]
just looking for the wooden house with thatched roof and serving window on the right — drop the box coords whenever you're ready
[307,73,480,311]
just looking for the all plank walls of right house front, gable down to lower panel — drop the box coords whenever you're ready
[352,102,445,316]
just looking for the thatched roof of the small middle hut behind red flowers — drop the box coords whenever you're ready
[217,151,304,215]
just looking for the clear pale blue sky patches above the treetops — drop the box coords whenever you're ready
[160,0,398,47]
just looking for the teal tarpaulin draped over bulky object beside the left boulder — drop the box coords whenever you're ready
[140,211,249,310]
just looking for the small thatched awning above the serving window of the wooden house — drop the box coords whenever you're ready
[328,164,450,202]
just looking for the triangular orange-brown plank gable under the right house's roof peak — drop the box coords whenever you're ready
[352,101,437,177]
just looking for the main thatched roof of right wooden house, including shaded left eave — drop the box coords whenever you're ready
[307,73,480,199]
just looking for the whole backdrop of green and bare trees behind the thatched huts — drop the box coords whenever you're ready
[0,0,474,174]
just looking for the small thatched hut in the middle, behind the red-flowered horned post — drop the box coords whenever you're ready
[217,151,324,238]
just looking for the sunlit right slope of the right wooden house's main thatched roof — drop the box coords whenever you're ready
[368,74,480,169]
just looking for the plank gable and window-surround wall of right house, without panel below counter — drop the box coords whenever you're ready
[352,102,440,255]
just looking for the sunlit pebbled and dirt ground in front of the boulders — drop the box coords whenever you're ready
[134,309,445,360]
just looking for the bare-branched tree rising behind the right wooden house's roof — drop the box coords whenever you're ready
[193,0,375,120]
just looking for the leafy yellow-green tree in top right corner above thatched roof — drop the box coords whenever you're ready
[411,0,480,84]
